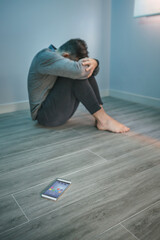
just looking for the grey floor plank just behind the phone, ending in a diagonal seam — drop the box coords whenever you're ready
[0,151,104,196]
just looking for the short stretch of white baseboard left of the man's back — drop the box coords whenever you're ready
[0,101,29,114]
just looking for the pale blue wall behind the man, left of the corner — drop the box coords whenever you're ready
[0,0,110,104]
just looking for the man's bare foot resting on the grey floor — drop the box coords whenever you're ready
[97,115,130,133]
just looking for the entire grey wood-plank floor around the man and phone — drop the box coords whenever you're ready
[0,97,160,240]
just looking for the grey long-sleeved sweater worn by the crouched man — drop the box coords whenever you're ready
[28,47,99,120]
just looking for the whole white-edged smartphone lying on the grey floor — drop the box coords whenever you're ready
[41,178,71,201]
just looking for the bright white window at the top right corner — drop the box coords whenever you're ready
[134,0,160,17]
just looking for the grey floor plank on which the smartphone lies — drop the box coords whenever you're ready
[14,143,160,219]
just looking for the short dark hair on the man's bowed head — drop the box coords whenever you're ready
[59,38,88,59]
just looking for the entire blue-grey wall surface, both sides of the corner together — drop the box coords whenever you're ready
[0,0,160,109]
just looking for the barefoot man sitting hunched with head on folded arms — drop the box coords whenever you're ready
[28,39,129,133]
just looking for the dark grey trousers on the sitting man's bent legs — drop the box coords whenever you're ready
[37,76,103,127]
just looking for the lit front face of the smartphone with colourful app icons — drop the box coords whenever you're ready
[43,180,70,198]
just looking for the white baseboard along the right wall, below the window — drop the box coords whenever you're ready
[109,89,160,108]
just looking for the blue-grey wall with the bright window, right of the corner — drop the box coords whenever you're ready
[110,0,160,98]
